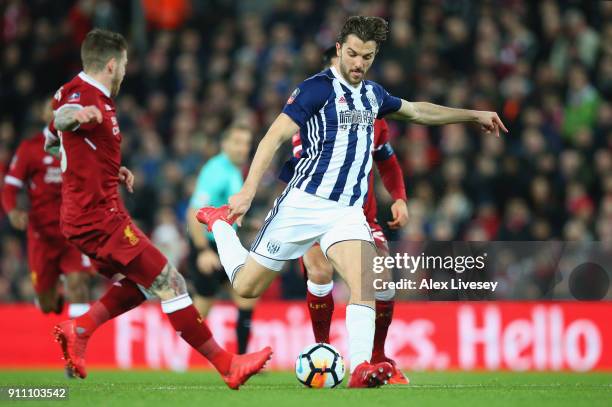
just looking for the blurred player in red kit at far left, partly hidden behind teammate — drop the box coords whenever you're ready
[2,104,91,318]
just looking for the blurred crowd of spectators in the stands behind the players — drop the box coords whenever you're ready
[0,0,612,301]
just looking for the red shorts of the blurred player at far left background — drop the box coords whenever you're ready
[28,229,92,294]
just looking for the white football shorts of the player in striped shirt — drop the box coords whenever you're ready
[249,188,374,271]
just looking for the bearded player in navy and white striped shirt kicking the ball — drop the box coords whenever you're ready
[197,16,507,387]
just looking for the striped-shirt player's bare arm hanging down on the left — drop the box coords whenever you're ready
[229,113,299,224]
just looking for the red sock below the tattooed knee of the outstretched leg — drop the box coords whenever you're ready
[167,305,234,375]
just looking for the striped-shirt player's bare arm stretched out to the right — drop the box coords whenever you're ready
[388,99,508,137]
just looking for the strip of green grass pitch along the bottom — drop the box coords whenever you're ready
[0,370,612,407]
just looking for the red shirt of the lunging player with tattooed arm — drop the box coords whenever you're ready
[53,72,123,227]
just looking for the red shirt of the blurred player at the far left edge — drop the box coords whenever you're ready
[2,129,62,236]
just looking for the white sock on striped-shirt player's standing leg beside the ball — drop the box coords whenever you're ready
[346,304,376,373]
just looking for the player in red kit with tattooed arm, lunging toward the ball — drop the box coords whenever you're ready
[47,29,272,389]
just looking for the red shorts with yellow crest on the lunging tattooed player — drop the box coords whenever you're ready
[62,214,168,288]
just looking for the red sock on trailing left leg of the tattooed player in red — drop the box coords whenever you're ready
[74,278,146,335]
